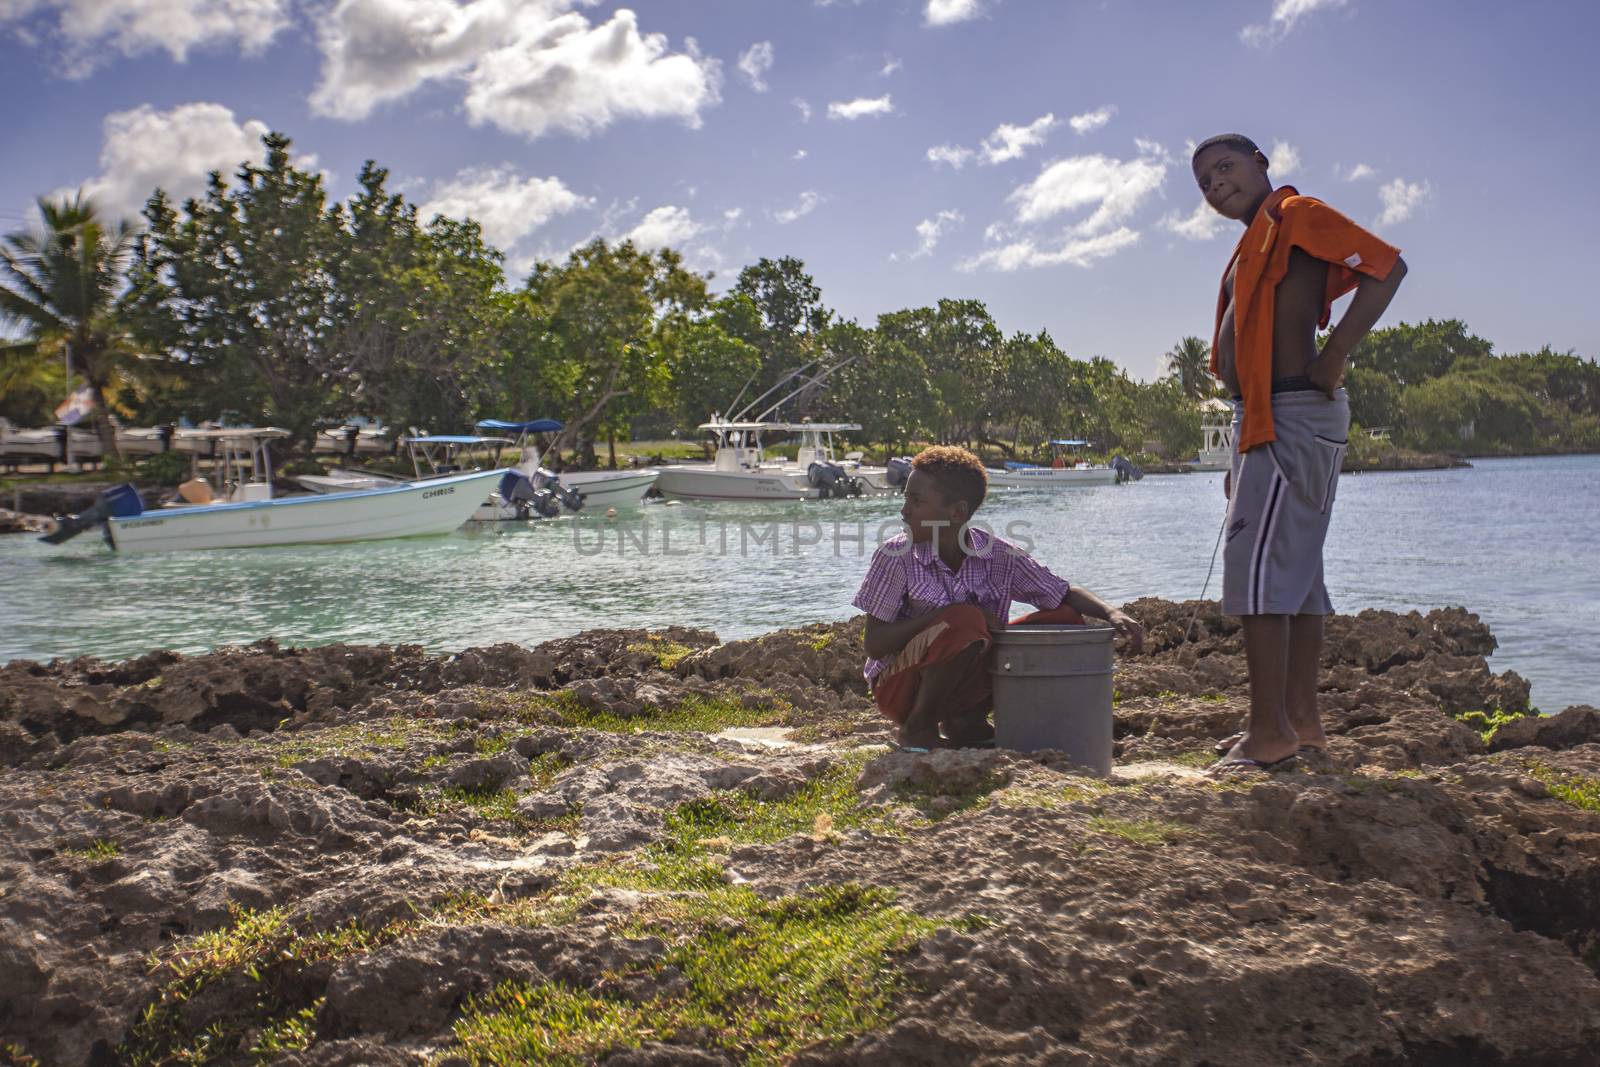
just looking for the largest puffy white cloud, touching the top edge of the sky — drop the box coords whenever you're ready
[310,0,722,139]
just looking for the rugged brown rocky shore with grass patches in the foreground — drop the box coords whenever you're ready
[0,600,1600,1067]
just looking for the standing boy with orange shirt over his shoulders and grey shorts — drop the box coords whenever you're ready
[1194,133,1406,773]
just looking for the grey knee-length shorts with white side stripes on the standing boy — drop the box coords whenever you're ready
[1222,389,1350,614]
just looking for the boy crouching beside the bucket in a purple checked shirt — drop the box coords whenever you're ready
[854,445,1144,752]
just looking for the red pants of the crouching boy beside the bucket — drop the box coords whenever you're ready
[872,605,1083,735]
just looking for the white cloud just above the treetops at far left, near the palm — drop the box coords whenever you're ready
[70,102,281,221]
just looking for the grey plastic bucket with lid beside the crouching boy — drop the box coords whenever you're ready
[992,624,1115,774]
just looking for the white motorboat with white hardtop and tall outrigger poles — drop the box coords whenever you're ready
[656,418,888,501]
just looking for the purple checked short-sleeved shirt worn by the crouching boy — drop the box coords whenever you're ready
[851,528,1072,681]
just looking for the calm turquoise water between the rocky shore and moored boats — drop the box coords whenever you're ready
[0,456,1600,710]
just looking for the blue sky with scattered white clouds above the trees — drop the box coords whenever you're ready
[0,0,1600,378]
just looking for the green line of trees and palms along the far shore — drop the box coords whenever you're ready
[0,133,1600,483]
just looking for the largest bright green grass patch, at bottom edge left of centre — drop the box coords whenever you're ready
[456,885,939,1067]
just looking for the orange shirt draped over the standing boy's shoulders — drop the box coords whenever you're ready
[1211,186,1400,451]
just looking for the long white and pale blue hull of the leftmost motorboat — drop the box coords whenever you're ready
[106,470,504,552]
